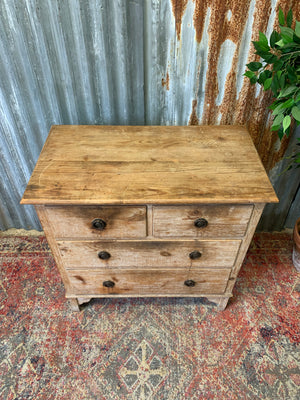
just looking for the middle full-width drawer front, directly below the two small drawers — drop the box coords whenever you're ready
[58,240,241,269]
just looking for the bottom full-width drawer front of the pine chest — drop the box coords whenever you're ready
[68,269,230,296]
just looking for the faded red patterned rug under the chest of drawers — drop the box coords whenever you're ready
[0,233,300,400]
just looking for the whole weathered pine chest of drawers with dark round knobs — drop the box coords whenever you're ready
[21,125,278,309]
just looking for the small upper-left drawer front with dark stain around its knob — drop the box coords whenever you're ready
[46,206,146,239]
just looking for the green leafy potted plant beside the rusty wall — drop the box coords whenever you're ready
[244,8,300,271]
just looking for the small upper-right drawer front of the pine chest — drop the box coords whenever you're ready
[153,205,253,238]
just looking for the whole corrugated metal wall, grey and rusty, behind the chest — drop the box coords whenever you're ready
[0,0,300,229]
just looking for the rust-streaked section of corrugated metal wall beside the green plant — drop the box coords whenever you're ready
[161,0,300,170]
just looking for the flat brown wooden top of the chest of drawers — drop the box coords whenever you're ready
[21,125,278,205]
